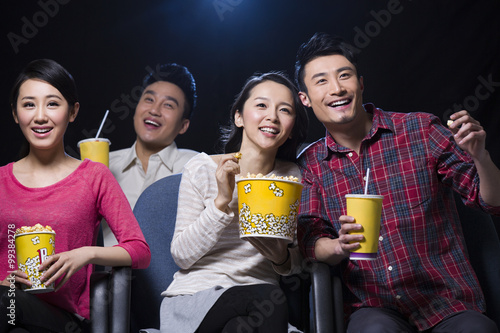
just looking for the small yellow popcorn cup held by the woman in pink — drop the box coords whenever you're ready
[15,231,56,294]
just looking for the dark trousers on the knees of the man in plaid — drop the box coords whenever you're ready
[347,308,498,333]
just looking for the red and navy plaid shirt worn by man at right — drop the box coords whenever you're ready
[298,104,500,330]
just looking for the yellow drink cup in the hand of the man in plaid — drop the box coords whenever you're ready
[345,194,384,260]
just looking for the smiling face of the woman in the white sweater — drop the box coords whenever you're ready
[235,81,296,152]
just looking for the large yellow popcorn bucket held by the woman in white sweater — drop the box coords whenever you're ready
[236,178,302,241]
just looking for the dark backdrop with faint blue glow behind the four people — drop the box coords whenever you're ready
[0,0,500,226]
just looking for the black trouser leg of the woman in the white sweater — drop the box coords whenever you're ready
[196,284,288,333]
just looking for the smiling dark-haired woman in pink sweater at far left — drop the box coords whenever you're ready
[0,59,151,332]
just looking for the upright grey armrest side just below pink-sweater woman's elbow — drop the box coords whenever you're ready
[109,266,132,333]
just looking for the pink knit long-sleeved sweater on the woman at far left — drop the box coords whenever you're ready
[0,160,151,318]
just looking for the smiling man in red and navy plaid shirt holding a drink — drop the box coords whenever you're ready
[296,34,500,333]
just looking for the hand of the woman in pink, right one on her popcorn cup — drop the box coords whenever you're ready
[39,247,91,291]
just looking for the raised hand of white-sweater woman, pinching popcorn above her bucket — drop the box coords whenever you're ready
[214,154,240,212]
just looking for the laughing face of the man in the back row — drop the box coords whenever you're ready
[134,81,189,152]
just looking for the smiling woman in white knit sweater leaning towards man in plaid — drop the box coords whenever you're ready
[161,72,308,333]
